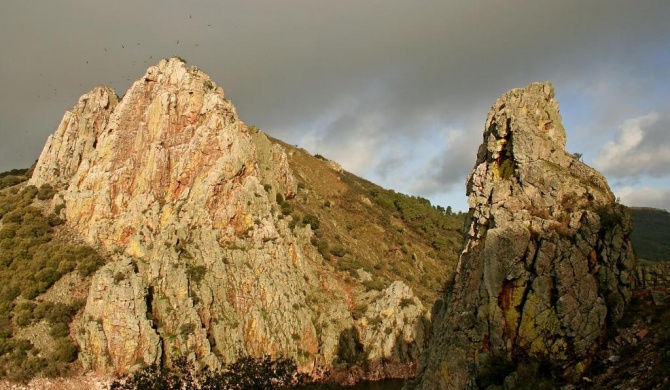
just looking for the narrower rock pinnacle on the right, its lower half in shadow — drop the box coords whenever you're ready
[415,83,635,389]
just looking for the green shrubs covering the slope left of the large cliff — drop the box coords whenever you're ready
[0,170,103,381]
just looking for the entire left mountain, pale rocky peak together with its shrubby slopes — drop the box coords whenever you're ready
[0,58,464,381]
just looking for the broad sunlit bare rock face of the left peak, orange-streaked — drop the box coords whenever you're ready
[32,58,424,378]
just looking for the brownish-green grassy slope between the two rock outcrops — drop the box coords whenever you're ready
[272,139,466,305]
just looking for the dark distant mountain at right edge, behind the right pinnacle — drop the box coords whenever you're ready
[631,207,670,261]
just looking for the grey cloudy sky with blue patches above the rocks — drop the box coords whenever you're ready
[0,0,670,210]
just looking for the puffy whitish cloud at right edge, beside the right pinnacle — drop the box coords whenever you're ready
[595,112,670,180]
